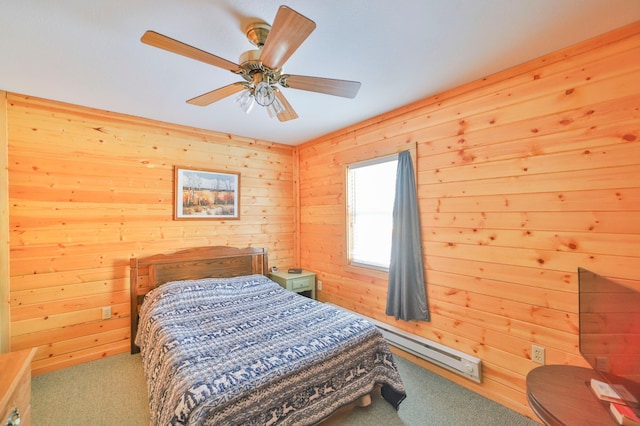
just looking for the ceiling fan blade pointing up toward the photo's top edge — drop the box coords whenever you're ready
[260,6,316,70]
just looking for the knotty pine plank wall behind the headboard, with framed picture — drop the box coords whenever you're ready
[7,93,296,374]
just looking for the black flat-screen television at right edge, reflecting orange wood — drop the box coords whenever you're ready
[578,268,640,408]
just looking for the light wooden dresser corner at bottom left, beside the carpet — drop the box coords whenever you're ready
[0,348,36,426]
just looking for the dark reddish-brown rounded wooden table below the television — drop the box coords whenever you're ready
[527,365,618,426]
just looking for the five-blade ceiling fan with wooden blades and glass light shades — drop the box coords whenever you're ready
[141,6,360,121]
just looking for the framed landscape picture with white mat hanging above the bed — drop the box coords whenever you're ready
[175,166,240,219]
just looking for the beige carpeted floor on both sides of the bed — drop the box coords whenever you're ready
[32,354,537,426]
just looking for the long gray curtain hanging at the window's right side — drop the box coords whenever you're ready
[386,151,430,321]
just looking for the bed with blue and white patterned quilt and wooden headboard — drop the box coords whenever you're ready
[131,247,406,425]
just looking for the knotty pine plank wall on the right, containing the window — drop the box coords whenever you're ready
[299,23,640,418]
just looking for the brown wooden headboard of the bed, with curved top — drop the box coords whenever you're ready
[130,246,269,354]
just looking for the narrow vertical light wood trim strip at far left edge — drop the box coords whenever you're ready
[0,91,11,354]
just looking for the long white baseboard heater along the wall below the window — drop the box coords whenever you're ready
[329,303,482,383]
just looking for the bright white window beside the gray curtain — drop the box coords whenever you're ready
[347,155,398,270]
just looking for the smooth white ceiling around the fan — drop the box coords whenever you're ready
[0,0,640,145]
